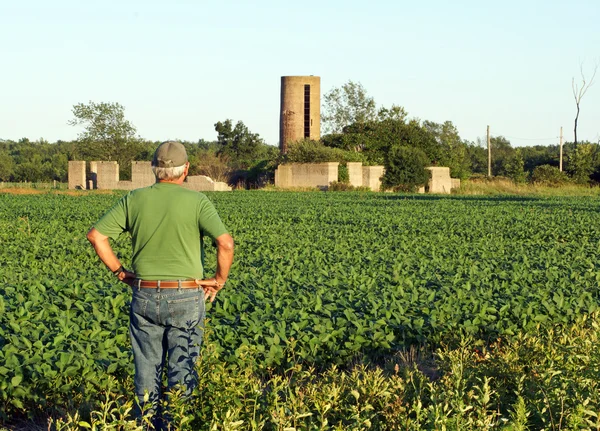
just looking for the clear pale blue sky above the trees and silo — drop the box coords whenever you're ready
[0,0,600,146]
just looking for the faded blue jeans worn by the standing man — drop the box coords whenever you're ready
[129,287,205,414]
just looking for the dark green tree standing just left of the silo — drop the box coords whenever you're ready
[215,119,268,169]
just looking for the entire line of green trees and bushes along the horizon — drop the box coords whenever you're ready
[0,87,600,191]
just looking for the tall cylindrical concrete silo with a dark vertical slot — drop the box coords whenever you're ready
[279,76,321,153]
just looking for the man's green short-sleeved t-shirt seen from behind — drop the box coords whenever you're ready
[94,183,227,280]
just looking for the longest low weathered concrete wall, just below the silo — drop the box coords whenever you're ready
[275,162,339,189]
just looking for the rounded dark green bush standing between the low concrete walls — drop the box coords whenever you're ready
[383,146,429,192]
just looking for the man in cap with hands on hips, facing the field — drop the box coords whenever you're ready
[87,141,234,426]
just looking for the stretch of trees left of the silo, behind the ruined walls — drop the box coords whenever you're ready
[0,102,279,186]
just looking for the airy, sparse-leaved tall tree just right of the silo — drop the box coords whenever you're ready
[321,81,378,134]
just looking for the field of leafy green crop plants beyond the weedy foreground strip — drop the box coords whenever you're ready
[0,192,600,428]
